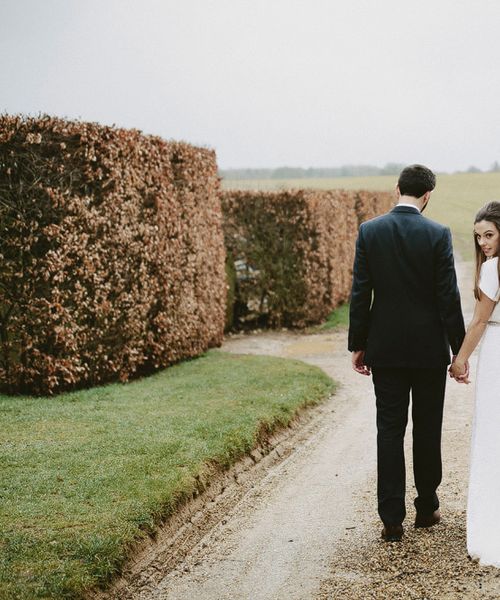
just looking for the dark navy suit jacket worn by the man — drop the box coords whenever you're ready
[349,206,465,368]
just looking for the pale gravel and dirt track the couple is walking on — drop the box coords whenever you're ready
[99,263,500,600]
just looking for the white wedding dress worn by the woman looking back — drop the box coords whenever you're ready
[467,257,500,567]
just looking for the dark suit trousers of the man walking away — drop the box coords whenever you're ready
[372,366,447,525]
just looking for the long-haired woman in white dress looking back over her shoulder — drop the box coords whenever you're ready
[450,202,500,567]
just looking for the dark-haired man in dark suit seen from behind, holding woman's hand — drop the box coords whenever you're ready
[349,165,465,541]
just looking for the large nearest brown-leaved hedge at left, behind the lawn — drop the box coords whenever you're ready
[0,115,226,393]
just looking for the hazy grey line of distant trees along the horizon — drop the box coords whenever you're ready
[219,161,500,179]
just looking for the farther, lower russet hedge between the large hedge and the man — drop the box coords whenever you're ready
[222,190,393,328]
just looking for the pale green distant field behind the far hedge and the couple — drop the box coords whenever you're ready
[223,173,500,260]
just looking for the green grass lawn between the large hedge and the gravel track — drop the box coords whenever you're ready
[0,350,333,600]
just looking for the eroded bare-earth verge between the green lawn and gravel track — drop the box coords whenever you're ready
[84,392,341,600]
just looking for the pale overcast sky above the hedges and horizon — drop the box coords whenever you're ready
[0,0,500,171]
